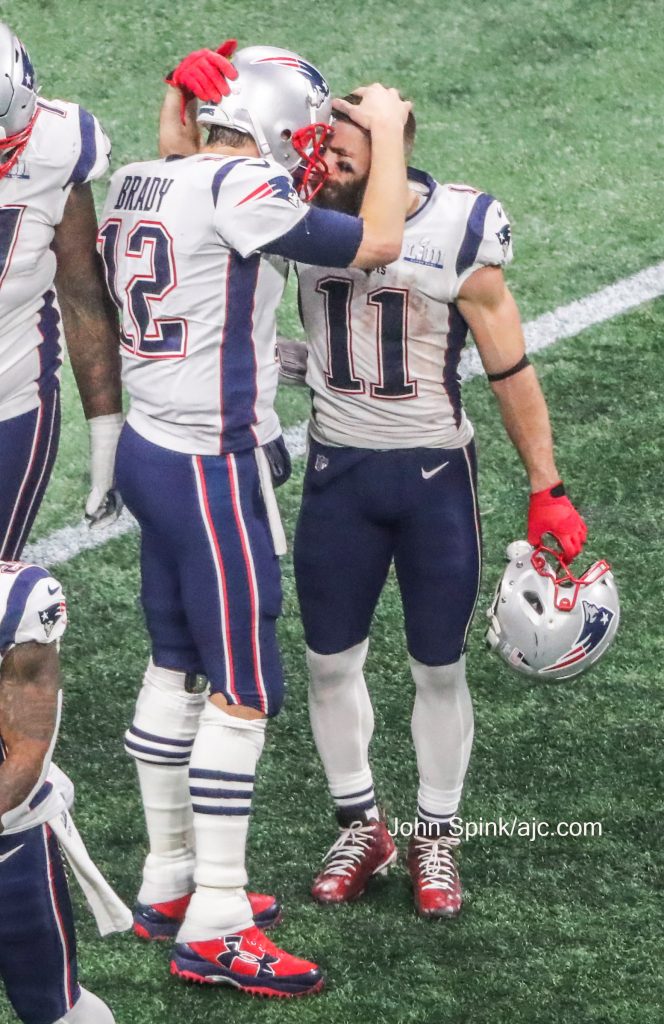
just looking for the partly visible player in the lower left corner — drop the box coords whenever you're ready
[0,561,131,1024]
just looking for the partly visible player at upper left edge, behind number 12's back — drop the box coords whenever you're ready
[0,23,122,559]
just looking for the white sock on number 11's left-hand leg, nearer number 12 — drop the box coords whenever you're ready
[306,640,378,824]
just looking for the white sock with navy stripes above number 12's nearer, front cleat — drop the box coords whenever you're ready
[177,700,266,942]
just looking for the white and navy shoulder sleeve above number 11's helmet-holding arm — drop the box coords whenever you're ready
[445,184,512,276]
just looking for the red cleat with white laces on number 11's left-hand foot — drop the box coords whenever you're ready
[312,821,397,903]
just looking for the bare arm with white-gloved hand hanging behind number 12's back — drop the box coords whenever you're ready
[53,184,122,420]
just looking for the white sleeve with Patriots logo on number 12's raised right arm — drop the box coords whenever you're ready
[212,158,307,258]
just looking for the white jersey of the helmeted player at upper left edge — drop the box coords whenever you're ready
[0,99,111,420]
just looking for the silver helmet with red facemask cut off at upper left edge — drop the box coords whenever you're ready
[0,22,38,177]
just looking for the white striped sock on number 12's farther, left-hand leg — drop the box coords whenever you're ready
[125,659,206,903]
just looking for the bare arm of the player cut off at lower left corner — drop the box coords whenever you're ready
[0,642,59,816]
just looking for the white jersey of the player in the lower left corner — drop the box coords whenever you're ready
[0,561,71,831]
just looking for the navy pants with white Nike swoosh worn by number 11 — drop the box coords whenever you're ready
[294,441,482,666]
